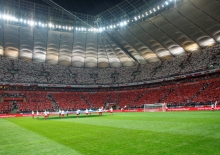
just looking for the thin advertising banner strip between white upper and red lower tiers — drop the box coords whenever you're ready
[0,69,220,88]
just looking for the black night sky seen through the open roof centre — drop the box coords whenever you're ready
[28,0,123,15]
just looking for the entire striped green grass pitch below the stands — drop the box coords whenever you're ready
[0,111,220,155]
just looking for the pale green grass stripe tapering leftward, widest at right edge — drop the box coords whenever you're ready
[53,111,220,139]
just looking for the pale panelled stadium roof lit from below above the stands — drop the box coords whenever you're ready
[0,0,220,67]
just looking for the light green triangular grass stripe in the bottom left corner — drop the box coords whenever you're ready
[0,118,80,155]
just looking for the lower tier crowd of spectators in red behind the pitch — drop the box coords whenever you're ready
[0,73,220,113]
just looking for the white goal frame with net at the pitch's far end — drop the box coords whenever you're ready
[144,103,166,112]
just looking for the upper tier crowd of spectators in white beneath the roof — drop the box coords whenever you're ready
[0,44,220,85]
